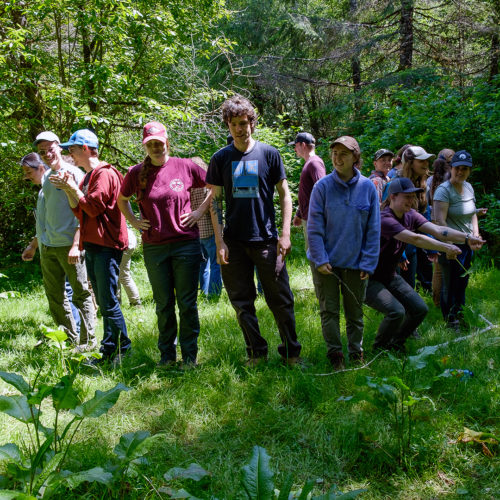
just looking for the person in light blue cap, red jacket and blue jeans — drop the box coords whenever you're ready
[50,129,131,365]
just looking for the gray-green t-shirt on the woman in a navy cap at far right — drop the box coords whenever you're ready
[434,181,476,234]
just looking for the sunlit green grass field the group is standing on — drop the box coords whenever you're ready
[0,234,500,499]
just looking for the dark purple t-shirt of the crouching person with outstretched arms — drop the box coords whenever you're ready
[370,207,429,283]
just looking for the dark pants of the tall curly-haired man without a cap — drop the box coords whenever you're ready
[221,239,301,358]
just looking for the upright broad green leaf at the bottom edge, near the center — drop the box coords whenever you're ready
[241,446,274,500]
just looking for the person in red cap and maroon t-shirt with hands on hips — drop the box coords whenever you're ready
[118,122,210,367]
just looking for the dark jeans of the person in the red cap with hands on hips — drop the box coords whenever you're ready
[143,240,201,362]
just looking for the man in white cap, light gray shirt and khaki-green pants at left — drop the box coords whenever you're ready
[22,131,95,350]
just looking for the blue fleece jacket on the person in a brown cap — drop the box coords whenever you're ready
[307,168,380,274]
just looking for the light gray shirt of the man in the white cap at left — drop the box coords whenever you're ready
[36,163,85,247]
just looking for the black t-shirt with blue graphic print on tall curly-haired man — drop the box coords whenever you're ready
[206,141,286,242]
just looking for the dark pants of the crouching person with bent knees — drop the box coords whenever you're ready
[365,274,429,347]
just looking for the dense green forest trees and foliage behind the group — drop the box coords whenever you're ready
[0,0,500,256]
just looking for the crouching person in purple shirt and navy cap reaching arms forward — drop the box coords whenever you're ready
[365,177,483,352]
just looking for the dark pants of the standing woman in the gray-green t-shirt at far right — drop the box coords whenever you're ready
[439,245,473,322]
